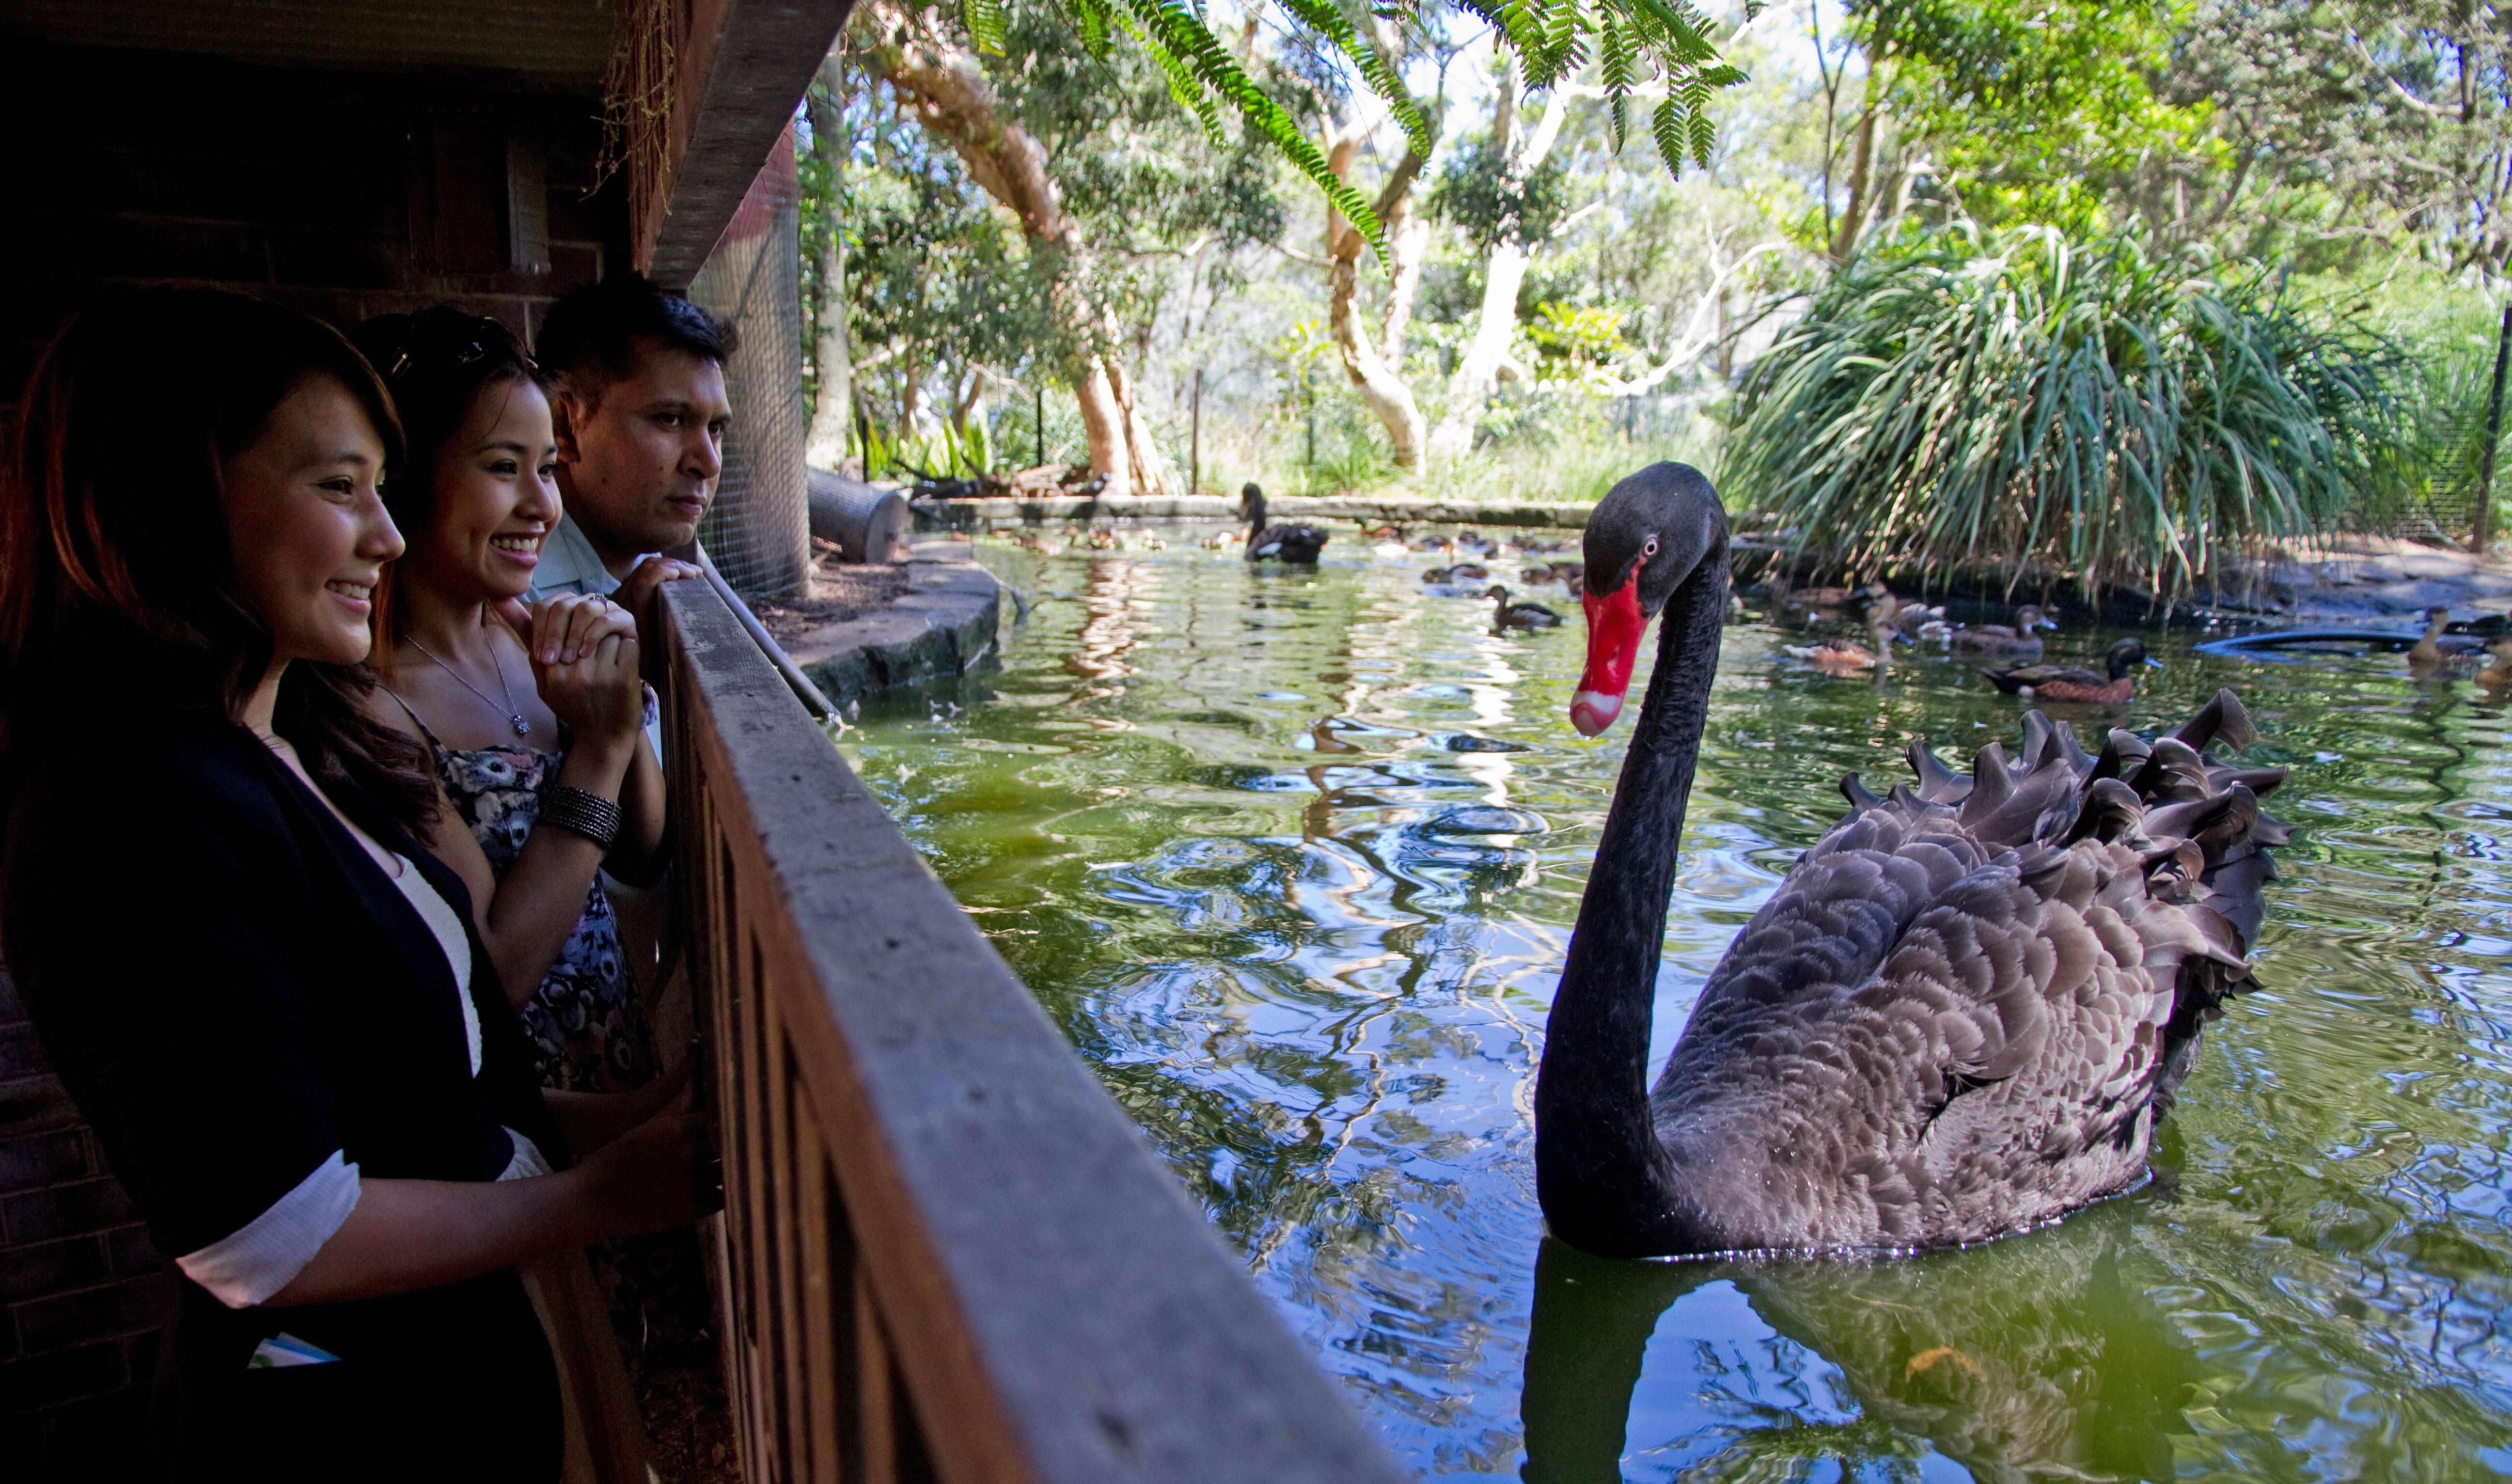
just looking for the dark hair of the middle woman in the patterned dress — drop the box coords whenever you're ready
[349,304,540,645]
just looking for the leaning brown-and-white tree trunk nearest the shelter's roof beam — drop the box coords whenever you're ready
[857,0,1176,495]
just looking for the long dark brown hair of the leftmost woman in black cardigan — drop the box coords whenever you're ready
[0,289,437,828]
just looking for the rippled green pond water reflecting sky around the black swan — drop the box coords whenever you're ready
[842,532,2512,1482]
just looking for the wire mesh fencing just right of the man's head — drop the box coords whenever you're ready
[688,128,811,597]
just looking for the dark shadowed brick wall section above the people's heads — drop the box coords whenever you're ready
[0,43,628,407]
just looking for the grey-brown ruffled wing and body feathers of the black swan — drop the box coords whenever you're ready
[1650,693,2283,1246]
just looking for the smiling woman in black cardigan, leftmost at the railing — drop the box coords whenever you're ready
[0,291,719,1479]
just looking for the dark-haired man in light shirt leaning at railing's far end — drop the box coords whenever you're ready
[533,274,734,625]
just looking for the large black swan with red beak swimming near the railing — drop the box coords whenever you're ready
[1535,465,2286,1258]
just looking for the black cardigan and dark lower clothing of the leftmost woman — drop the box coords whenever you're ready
[0,711,565,1479]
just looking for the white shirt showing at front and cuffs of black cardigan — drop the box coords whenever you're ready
[173,854,550,1308]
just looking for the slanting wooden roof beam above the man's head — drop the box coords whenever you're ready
[636,0,854,289]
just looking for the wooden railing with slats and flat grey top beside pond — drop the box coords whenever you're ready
[663,582,1402,1484]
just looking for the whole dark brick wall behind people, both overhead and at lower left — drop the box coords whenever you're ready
[0,43,628,1484]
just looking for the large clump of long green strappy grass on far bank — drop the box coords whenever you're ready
[1721,226,2404,593]
